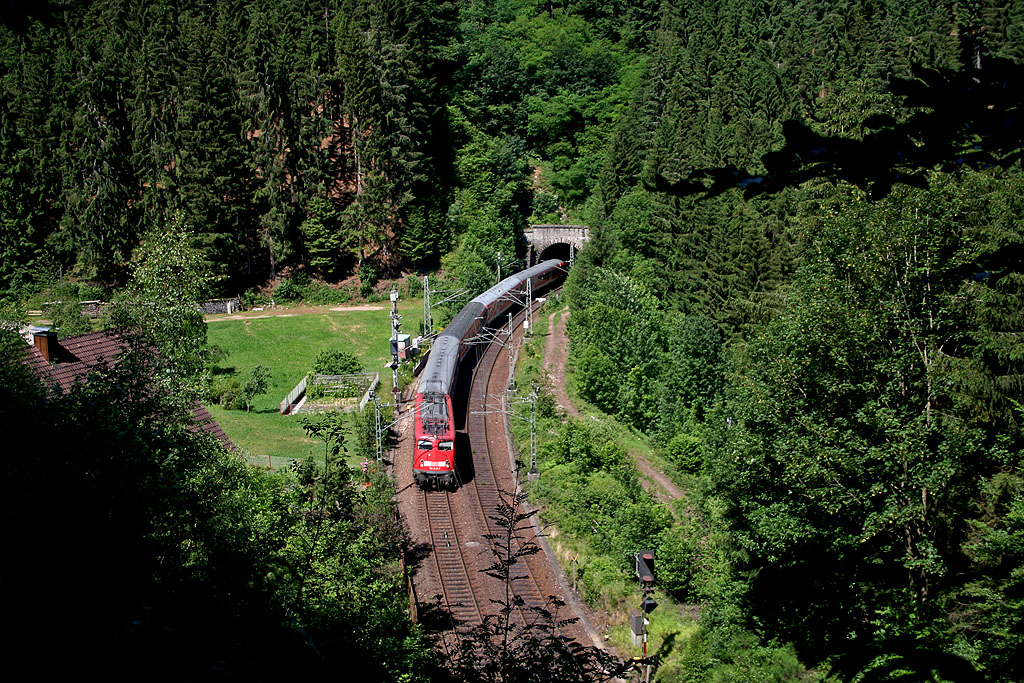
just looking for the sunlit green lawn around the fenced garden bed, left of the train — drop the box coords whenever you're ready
[207,299,423,467]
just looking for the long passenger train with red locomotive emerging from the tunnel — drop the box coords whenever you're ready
[413,259,565,488]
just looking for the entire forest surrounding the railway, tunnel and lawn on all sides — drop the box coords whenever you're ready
[0,0,1024,683]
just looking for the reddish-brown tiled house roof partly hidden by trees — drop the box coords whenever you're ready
[24,332,237,451]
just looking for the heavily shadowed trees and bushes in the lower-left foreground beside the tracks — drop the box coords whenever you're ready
[0,333,429,680]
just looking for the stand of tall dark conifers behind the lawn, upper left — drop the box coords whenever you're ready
[0,0,451,292]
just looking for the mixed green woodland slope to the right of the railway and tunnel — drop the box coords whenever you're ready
[568,1,1024,681]
